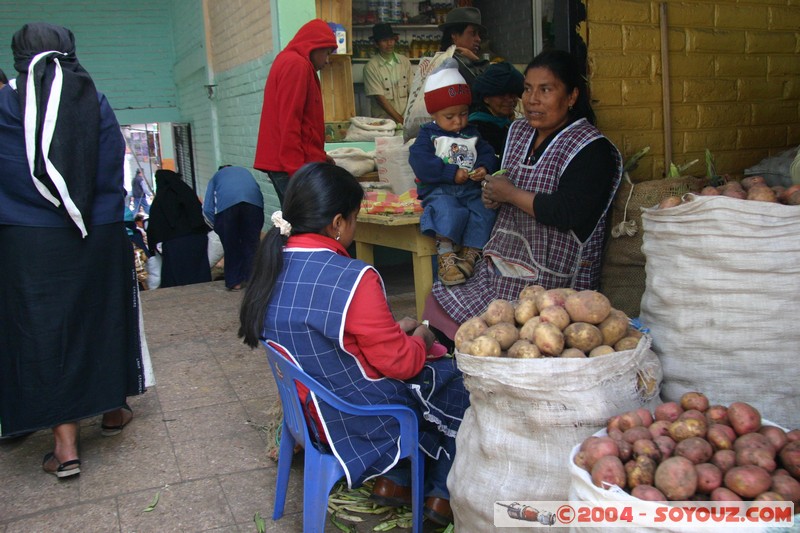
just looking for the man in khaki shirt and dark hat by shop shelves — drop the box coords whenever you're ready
[364,23,411,124]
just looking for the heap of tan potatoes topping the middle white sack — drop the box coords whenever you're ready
[455,285,642,359]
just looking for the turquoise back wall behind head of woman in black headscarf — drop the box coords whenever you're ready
[0,0,179,124]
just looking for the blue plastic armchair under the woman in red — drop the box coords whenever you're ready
[262,341,424,533]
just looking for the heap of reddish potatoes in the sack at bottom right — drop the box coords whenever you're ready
[574,392,800,504]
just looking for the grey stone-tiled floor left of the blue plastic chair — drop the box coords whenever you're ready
[0,265,438,533]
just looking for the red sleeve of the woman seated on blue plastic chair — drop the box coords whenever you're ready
[344,269,427,379]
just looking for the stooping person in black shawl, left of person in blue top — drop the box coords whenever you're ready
[147,170,211,287]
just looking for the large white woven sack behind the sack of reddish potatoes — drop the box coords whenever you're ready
[641,195,800,428]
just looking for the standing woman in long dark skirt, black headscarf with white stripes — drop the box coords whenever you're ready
[0,23,145,478]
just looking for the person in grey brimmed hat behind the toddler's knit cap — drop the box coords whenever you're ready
[439,7,489,87]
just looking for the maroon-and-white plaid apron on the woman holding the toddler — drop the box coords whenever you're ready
[433,119,622,323]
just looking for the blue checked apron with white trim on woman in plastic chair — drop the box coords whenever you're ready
[263,248,469,488]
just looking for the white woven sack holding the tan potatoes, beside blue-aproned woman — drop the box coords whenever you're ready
[447,335,661,533]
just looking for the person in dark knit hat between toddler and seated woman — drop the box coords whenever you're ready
[469,63,525,157]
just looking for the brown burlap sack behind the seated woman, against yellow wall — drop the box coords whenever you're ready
[600,173,708,317]
